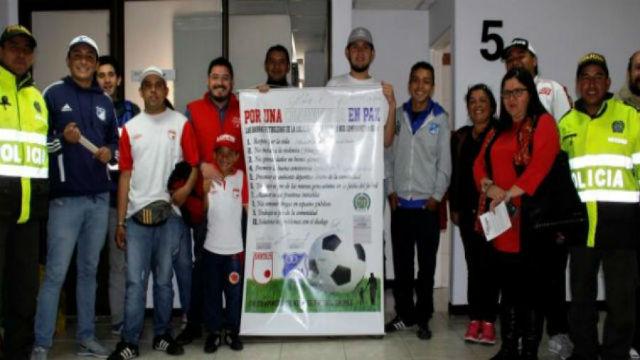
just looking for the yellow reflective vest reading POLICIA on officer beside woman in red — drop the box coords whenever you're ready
[558,98,640,247]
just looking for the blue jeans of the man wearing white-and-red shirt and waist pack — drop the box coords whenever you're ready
[122,215,182,345]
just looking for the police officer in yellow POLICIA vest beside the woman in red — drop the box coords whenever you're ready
[559,53,640,360]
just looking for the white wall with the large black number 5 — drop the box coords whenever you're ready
[451,0,640,305]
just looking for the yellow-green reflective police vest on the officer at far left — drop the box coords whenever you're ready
[0,66,49,223]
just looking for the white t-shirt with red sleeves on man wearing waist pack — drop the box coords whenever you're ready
[119,109,198,217]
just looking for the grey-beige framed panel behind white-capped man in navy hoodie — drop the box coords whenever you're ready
[32,10,109,90]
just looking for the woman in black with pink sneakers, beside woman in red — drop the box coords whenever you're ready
[449,84,498,345]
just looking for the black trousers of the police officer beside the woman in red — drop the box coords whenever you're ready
[569,246,638,360]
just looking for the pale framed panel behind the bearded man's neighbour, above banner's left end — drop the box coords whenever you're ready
[229,15,292,90]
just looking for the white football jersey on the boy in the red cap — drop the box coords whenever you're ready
[204,170,247,255]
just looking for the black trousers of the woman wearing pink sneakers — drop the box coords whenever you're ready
[460,219,499,322]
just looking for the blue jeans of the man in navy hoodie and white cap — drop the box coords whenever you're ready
[35,192,109,348]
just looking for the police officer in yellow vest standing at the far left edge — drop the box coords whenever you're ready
[0,25,49,359]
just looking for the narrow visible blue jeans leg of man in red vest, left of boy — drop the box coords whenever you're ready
[173,219,193,314]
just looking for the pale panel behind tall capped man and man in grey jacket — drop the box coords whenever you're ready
[350,10,430,105]
